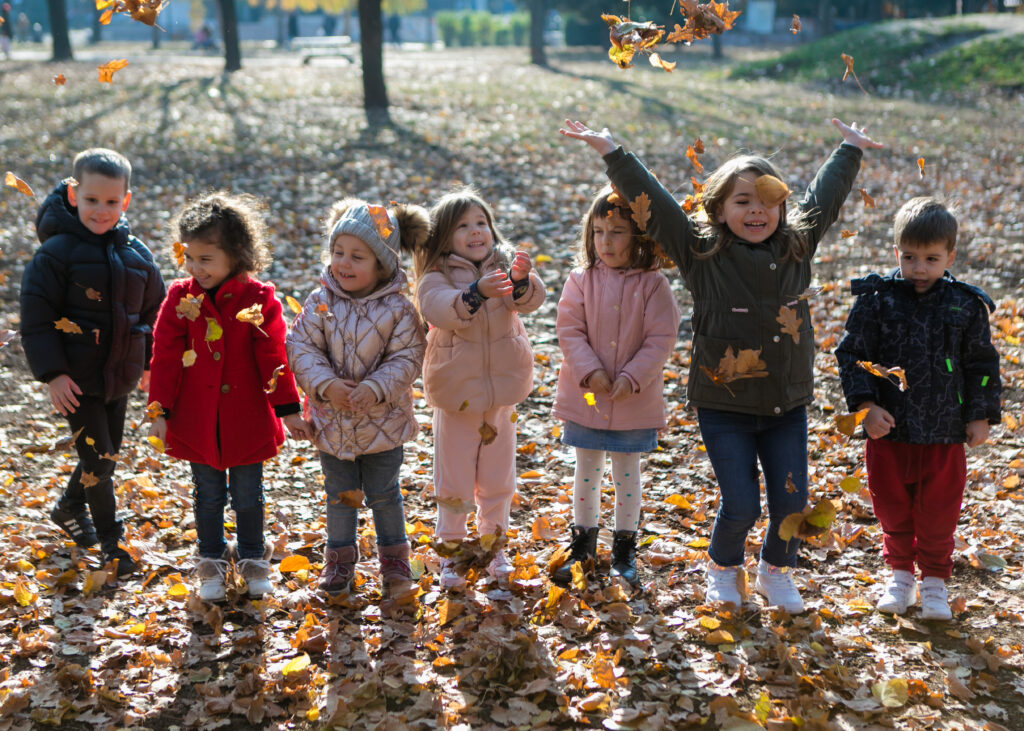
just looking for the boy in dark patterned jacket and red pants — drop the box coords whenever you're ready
[836,198,1000,619]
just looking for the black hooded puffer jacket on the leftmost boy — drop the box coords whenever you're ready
[22,183,165,400]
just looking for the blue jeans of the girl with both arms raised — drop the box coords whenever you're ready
[697,406,807,566]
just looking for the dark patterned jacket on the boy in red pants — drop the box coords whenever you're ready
[836,269,1000,444]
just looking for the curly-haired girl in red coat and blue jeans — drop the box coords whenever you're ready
[150,192,310,601]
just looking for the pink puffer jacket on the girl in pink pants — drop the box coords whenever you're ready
[416,252,547,412]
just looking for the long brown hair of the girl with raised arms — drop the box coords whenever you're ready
[693,155,811,261]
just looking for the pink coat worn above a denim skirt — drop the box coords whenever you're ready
[554,261,679,430]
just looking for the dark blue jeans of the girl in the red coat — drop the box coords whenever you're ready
[191,462,263,558]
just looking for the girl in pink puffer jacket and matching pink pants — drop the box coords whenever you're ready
[416,189,546,588]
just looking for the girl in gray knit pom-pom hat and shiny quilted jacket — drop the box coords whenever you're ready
[286,199,430,597]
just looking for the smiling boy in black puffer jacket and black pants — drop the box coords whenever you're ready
[22,147,165,575]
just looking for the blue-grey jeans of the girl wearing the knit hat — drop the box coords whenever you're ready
[321,446,409,548]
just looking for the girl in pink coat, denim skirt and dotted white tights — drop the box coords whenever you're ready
[553,187,679,586]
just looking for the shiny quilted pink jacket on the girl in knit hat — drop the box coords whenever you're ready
[286,266,425,460]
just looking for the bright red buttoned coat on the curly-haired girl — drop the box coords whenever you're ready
[150,274,299,470]
